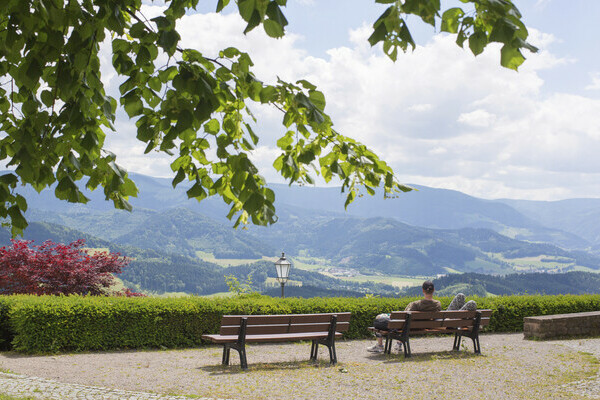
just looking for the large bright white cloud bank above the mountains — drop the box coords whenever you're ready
[101,9,600,199]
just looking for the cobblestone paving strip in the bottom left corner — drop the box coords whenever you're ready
[0,372,230,400]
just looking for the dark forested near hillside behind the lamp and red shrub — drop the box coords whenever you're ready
[0,222,397,296]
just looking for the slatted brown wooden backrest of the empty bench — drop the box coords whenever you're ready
[220,312,351,335]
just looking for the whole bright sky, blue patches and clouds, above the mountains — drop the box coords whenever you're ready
[102,0,600,200]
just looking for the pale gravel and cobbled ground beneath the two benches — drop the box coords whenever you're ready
[0,334,600,400]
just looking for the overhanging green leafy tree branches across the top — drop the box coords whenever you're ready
[0,0,537,234]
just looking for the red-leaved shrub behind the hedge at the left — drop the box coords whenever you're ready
[0,239,131,295]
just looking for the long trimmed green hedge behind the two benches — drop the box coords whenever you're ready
[0,295,600,353]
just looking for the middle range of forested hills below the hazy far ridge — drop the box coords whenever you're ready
[19,207,600,276]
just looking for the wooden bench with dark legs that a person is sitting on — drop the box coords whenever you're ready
[369,310,492,357]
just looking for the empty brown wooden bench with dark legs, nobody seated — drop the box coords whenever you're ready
[202,312,350,369]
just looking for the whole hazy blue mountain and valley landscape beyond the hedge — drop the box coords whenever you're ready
[7,175,600,294]
